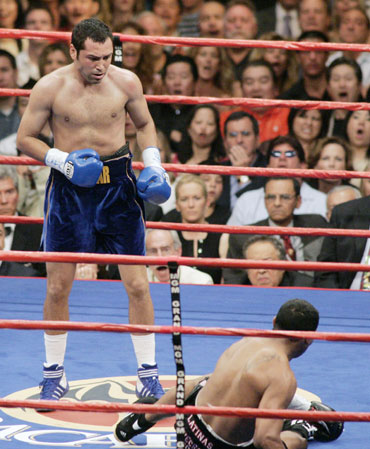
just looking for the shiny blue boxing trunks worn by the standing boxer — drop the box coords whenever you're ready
[41,144,145,256]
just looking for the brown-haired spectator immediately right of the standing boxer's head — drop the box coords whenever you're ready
[114,22,155,95]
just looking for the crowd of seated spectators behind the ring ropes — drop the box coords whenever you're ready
[0,0,370,288]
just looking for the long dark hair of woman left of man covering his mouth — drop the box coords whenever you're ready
[178,104,225,164]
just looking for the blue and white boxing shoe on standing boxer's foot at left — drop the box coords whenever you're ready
[37,364,69,412]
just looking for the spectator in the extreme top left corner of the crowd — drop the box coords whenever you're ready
[0,0,28,57]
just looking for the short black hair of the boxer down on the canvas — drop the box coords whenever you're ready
[274,299,319,331]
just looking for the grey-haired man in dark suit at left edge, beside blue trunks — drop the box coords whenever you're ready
[0,165,45,276]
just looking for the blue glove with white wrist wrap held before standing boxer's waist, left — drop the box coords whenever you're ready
[45,148,103,187]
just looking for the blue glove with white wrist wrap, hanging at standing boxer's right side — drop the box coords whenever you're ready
[137,147,171,204]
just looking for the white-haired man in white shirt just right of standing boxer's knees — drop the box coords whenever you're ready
[145,229,213,284]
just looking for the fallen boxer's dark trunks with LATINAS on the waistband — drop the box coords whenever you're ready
[184,378,255,449]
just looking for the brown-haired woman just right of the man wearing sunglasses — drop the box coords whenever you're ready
[307,137,352,194]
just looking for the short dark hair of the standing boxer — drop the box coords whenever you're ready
[72,17,113,56]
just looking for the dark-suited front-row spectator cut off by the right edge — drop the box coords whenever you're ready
[315,196,370,289]
